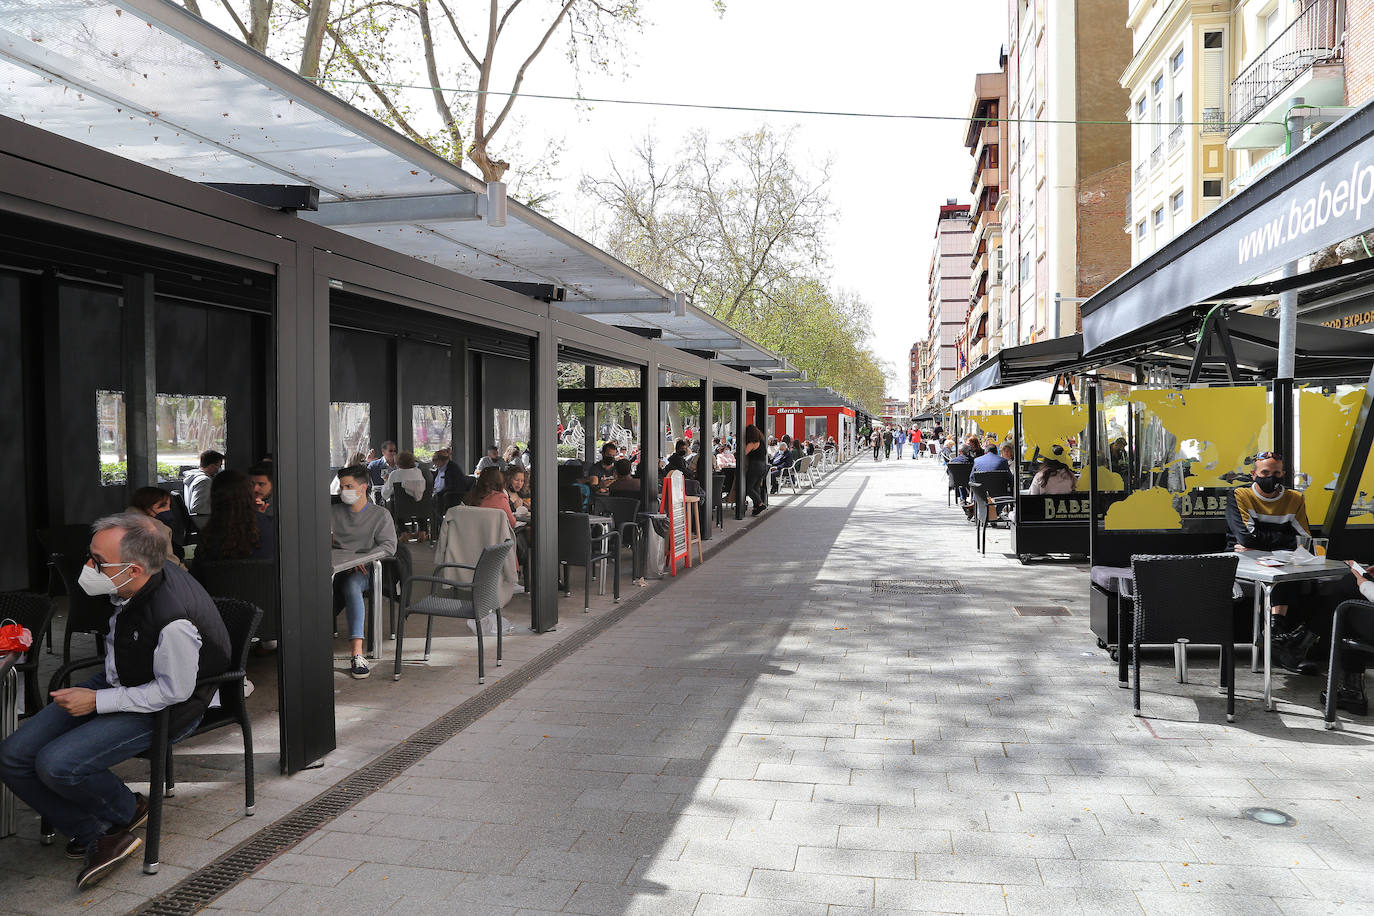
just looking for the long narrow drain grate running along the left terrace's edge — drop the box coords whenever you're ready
[133,585,665,916]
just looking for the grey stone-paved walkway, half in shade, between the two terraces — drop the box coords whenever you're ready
[11,460,1374,916]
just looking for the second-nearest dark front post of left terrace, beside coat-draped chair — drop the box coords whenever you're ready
[525,333,558,633]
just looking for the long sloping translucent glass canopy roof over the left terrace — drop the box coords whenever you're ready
[0,0,846,385]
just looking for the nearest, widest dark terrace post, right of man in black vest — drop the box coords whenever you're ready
[273,243,335,773]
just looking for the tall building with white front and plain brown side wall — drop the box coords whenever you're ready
[999,0,1143,343]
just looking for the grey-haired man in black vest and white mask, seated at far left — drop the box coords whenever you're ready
[0,512,229,889]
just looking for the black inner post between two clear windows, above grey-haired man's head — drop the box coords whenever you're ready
[122,273,156,496]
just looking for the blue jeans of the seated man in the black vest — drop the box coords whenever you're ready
[0,674,195,843]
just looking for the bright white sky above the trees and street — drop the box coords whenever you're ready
[518,0,1006,397]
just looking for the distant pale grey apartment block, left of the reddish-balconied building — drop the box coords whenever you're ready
[921,201,973,412]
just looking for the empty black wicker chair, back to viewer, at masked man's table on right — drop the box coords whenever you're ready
[1118,553,1239,722]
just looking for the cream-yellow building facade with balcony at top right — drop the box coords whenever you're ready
[1121,0,1374,264]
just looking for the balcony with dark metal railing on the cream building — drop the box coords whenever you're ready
[1227,0,1345,150]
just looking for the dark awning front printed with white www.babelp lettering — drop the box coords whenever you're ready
[1083,102,1374,353]
